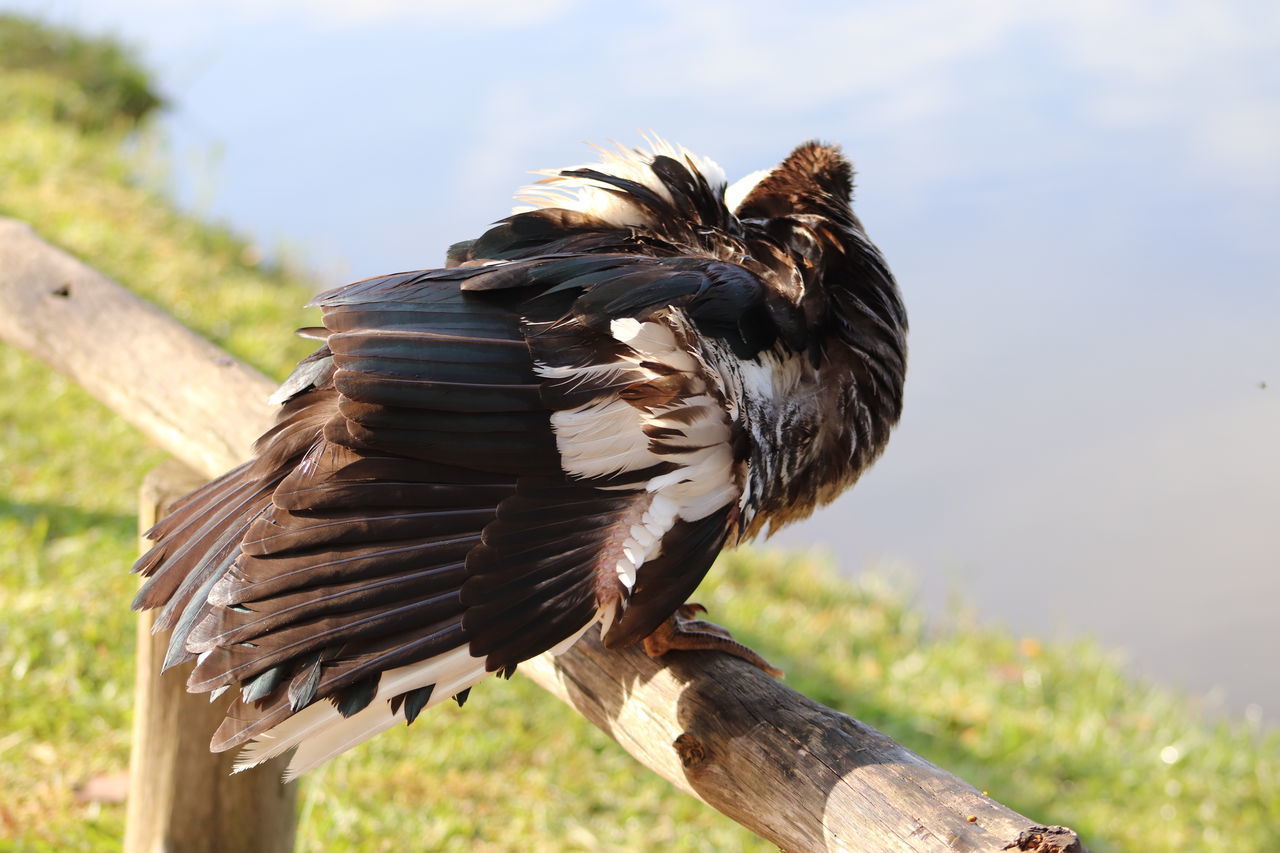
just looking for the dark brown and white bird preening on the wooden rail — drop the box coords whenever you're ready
[134,137,908,777]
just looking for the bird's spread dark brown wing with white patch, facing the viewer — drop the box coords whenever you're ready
[137,204,799,774]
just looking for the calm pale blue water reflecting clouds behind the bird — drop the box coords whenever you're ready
[10,0,1280,720]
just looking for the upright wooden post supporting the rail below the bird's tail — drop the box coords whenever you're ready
[124,462,298,853]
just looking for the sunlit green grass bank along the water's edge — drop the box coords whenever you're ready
[0,14,1280,852]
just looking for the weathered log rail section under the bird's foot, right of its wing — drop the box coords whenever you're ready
[520,630,1080,852]
